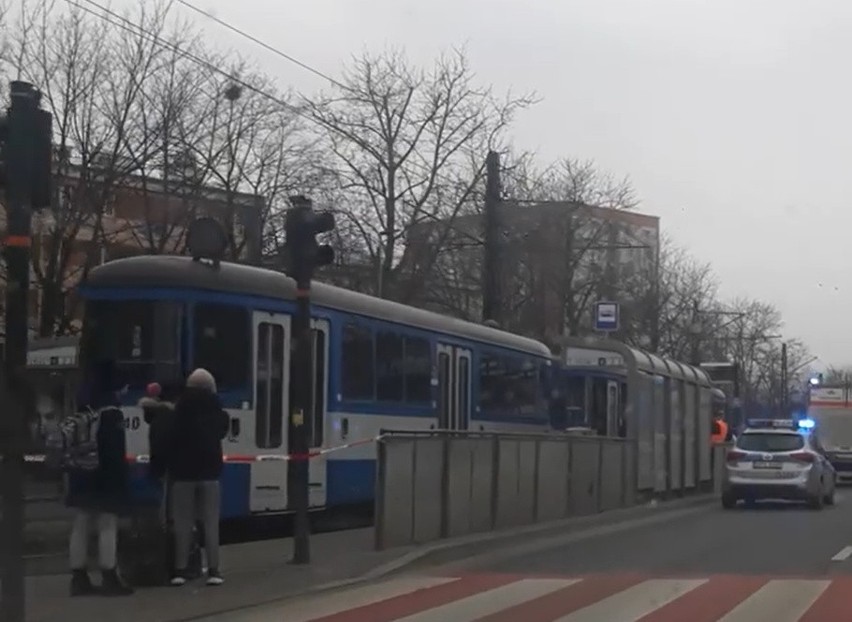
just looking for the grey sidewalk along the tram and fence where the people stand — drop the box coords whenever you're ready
[21,495,715,622]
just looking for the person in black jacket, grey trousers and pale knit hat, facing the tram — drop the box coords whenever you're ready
[166,368,229,586]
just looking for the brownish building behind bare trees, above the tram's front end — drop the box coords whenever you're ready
[0,157,264,336]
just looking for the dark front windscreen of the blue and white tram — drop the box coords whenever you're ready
[80,300,182,390]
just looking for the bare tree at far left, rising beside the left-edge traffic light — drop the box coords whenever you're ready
[4,0,186,335]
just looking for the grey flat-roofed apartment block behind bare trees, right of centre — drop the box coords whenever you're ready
[403,201,660,342]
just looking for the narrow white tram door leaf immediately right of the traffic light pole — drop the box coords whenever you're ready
[305,320,328,507]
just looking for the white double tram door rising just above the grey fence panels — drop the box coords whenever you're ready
[438,344,471,430]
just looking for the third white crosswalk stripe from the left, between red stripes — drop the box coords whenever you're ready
[555,579,704,622]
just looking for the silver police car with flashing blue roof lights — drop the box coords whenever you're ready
[722,419,836,510]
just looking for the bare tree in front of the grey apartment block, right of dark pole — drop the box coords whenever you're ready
[480,154,638,337]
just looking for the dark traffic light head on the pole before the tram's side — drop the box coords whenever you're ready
[284,196,334,289]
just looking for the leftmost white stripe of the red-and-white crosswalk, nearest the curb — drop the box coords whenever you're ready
[210,577,458,622]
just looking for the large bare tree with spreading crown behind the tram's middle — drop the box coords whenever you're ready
[306,50,534,300]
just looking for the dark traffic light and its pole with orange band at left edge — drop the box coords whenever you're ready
[0,81,52,622]
